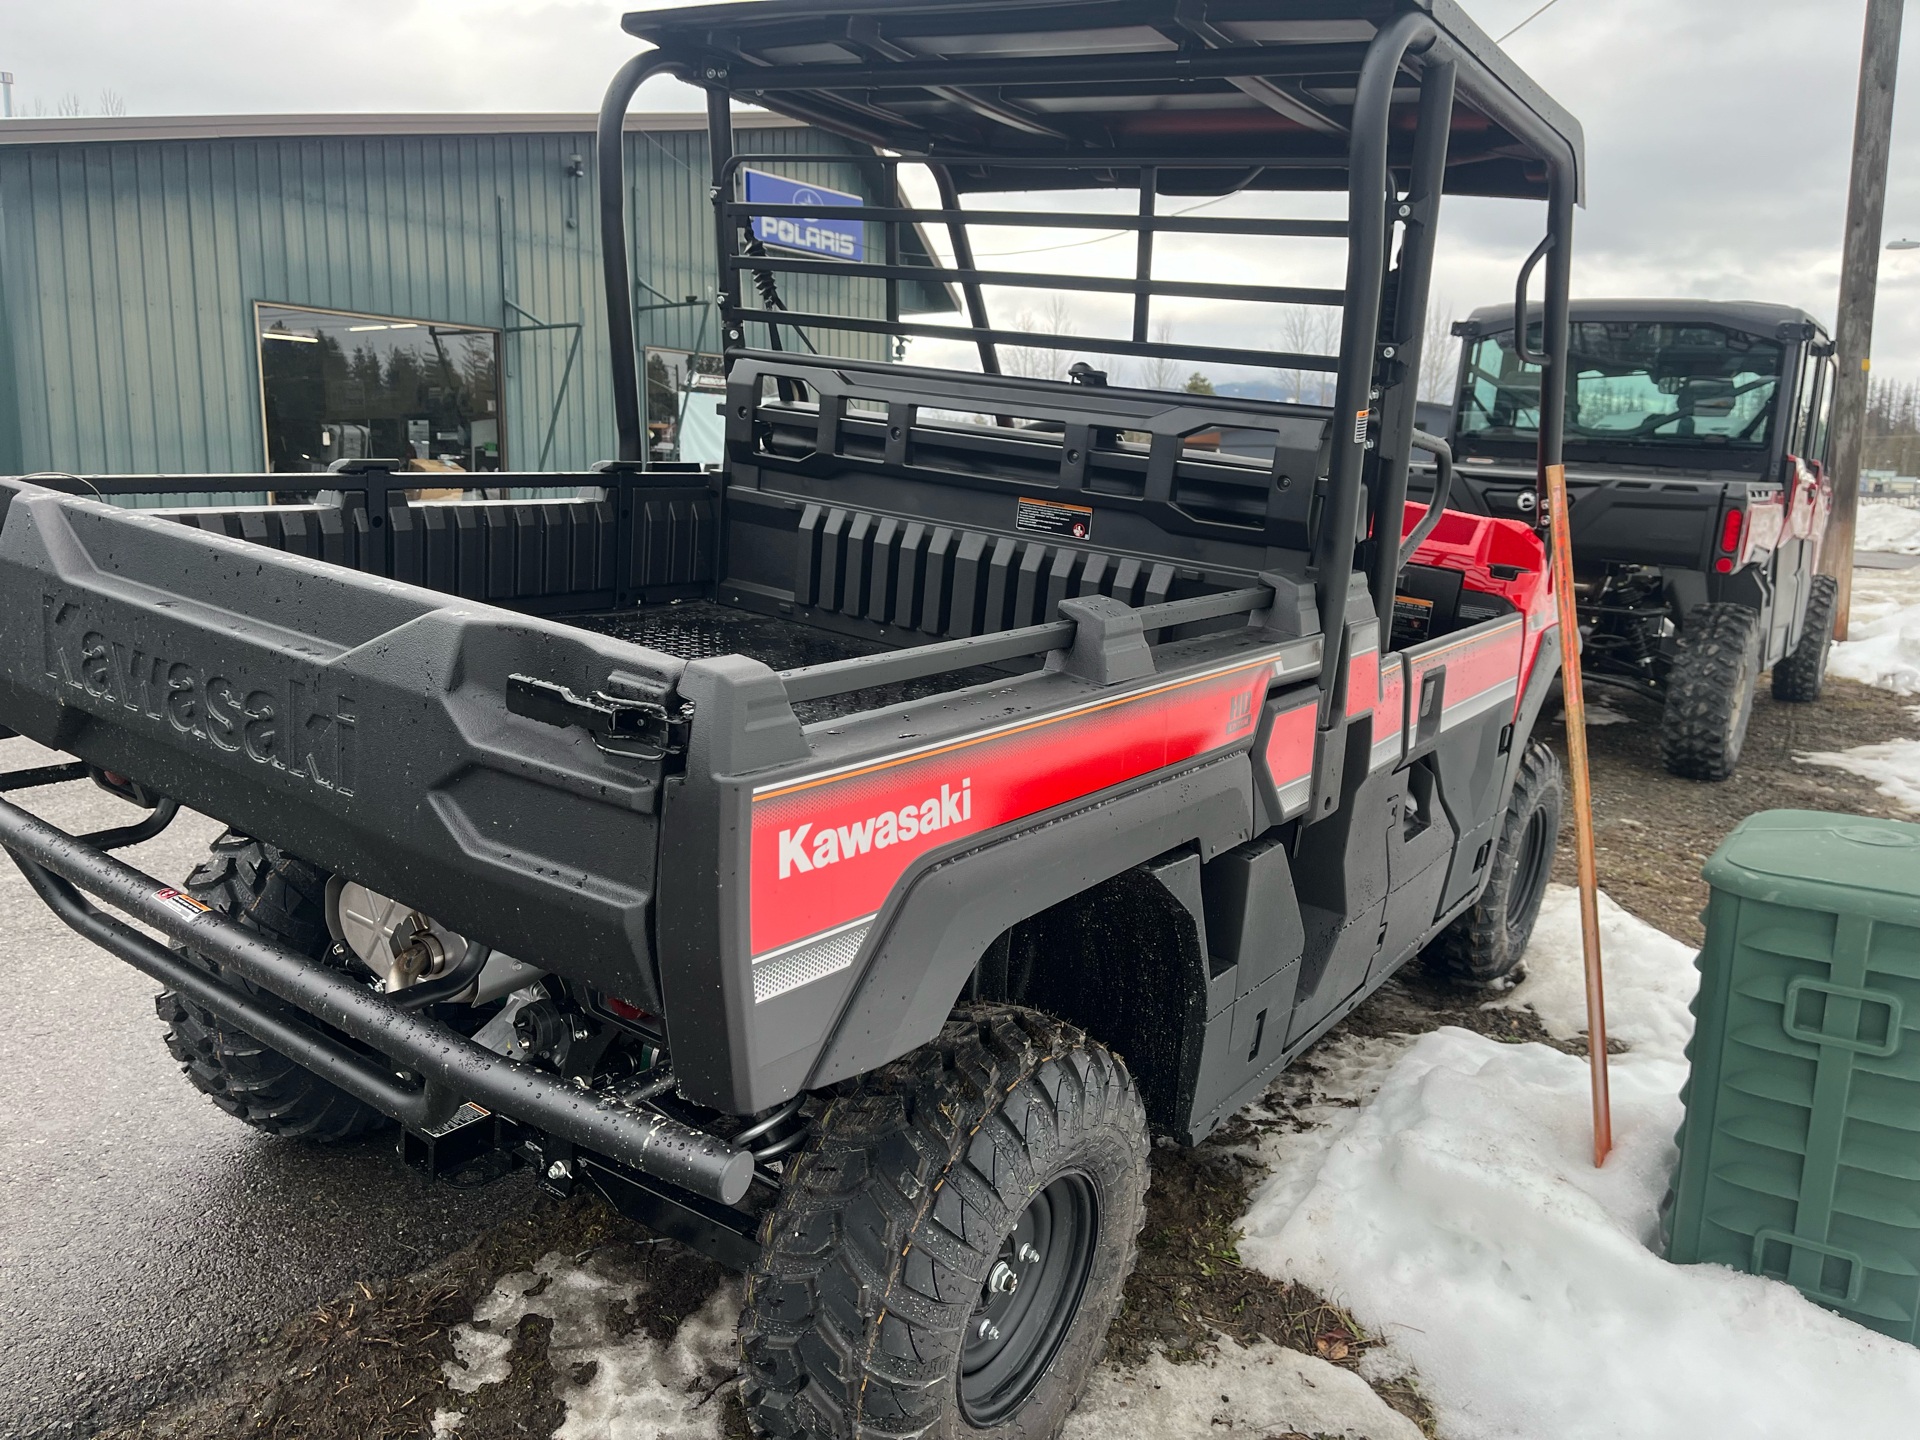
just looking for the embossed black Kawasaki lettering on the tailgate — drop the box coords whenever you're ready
[40,595,355,795]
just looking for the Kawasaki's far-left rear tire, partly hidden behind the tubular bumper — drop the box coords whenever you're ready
[154,831,392,1144]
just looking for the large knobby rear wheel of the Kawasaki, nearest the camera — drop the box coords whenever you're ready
[741,1006,1150,1440]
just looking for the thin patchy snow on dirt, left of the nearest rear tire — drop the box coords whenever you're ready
[436,1252,739,1440]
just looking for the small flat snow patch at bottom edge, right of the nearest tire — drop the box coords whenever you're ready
[1060,1336,1421,1440]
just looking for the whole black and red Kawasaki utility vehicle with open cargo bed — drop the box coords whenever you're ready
[0,0,1580,1436]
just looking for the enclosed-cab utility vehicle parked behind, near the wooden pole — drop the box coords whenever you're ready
[1415,300,1837,780]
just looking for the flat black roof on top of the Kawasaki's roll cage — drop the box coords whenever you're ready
[624,0,1584,196]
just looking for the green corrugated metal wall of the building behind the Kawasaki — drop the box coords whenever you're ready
[0,127,898,474]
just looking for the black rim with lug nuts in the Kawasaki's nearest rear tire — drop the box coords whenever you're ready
[960,1173,1100,1427]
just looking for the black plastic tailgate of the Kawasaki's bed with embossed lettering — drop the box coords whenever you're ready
[0,482,682,1008]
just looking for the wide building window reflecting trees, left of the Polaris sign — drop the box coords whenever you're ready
[253,303,505,474]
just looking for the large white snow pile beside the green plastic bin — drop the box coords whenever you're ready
[1240,891,1920,1440]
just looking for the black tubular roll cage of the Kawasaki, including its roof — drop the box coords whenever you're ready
[599,0,1584,722]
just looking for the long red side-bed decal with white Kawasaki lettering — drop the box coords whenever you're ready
[749,657,1273,956]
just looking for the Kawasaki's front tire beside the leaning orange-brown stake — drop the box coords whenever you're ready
[1425,739,1565,989]
